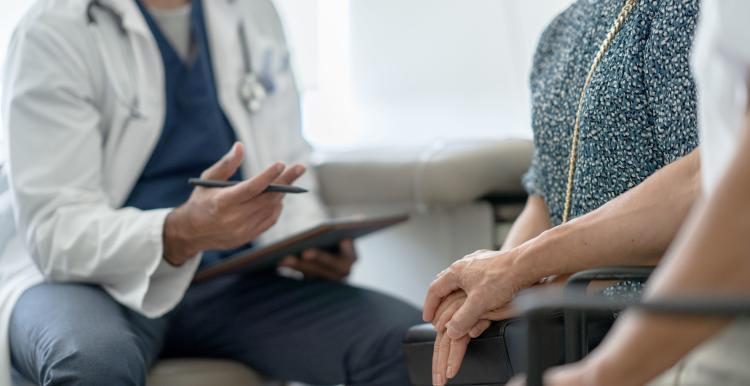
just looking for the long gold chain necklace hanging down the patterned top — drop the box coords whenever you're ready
[562,0,638,223]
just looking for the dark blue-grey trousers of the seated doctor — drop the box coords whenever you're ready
[10,274,420,386]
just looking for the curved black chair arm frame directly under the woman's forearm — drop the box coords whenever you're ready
[565,266,655,363]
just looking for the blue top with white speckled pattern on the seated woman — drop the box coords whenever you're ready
[524,0,698,225]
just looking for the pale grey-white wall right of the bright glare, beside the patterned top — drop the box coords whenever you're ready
[350,0,568,147]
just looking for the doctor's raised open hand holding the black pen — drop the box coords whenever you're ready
[163,143,305,266]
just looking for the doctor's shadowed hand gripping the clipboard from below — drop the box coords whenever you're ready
[279,240,357,281]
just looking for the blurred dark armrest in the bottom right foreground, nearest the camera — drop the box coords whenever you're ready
[514,290,750,386]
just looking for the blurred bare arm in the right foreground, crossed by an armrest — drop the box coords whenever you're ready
[536,114,750,385]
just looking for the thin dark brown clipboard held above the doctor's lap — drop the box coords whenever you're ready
[193,214,409,283]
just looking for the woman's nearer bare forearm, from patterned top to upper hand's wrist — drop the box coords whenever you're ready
[520,149,700,278]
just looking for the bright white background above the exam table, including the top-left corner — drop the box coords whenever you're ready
[0,0,570,149]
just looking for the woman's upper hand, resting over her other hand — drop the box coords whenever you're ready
[423,250,538,339]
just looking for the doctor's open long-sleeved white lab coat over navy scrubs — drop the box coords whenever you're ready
[0,0,326,385]
